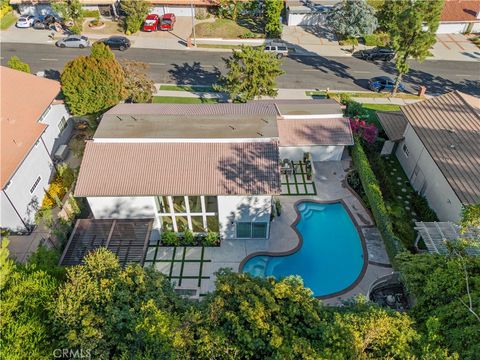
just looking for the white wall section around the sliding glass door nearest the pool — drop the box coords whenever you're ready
[218,195,272,239]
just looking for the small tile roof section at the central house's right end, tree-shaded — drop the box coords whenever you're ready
[277,118,353,146]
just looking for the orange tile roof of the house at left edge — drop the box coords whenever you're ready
[0,66,60,189]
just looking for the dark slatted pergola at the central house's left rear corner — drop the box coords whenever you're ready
[60,219,153,266]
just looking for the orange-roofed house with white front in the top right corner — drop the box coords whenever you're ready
[437,0,480,34]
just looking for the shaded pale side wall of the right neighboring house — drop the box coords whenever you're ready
[396,125,462,221]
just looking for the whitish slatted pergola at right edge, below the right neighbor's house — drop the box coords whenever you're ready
[415,221,480,256]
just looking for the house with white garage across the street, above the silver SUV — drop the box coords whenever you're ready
[285,0,341,26]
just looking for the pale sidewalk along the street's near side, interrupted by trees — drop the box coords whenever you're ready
[155,84,422,105]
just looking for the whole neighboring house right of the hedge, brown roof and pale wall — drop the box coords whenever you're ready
[378,91,480,222]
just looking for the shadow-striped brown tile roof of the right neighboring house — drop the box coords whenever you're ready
[401,91,480,204]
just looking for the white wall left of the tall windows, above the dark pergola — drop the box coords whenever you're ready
[87,196,155,219]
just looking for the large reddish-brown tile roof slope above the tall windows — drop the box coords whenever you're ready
[75,141,281,196]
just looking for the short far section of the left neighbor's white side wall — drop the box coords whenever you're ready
[40,104,73,156]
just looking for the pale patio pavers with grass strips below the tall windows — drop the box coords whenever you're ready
[144,242,211,288]
